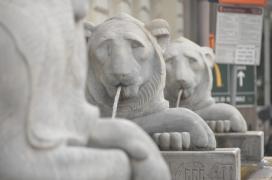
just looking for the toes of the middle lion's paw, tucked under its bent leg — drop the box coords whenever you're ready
[152,132,191,151]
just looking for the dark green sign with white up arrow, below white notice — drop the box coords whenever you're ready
[212,64,255,106]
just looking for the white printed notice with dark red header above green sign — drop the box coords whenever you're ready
[215,5,263,65]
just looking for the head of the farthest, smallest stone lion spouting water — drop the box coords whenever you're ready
[164,37,214,110]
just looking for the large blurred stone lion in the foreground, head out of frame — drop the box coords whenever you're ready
[0,0,170,180]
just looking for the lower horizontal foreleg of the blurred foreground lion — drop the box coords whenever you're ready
[0,142,132,180]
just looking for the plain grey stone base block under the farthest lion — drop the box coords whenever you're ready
[215,131,264,164]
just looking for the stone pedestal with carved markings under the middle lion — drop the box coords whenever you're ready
[162,148,240,180]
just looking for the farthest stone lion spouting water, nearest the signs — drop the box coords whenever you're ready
[164,37,247,132]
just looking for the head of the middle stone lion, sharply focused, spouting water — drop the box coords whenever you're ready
[87,14,170,118]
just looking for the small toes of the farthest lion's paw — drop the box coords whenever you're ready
[206,120,231,133]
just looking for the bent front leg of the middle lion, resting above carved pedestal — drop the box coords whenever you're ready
[133,108,216,150]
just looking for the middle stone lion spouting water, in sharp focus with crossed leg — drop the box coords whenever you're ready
[86,14,216,149]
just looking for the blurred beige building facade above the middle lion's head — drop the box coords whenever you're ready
[87,0,190,38]
